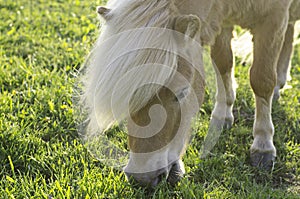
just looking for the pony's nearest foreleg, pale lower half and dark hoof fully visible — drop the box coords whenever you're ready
[250,15,287,169]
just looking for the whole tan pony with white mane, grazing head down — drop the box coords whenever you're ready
[83,0,300,186]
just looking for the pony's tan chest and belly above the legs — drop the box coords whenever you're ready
[175,0,299,45]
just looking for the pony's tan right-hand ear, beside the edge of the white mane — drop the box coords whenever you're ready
[173,15,201,38]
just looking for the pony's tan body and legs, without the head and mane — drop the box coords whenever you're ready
[177,0,300,167]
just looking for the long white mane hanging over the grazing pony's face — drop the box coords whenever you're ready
[83,0,177,136]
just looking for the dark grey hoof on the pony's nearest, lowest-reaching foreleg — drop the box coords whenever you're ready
[250,152,276,171]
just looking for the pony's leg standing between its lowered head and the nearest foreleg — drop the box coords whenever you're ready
[211,27,235,128]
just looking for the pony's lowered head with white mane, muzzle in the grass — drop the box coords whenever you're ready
[84,0,204,186]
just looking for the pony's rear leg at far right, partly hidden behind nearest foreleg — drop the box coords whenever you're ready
[273,23,295,100]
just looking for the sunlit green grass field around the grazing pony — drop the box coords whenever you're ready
[0,0,300,199]
